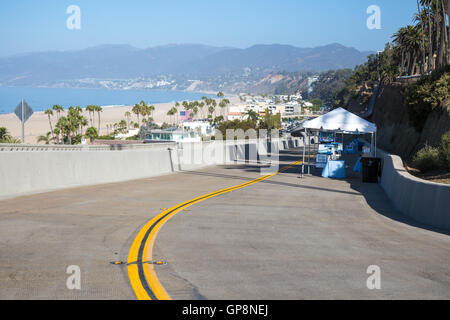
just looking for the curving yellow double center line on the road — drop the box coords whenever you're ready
[127,161,301,300]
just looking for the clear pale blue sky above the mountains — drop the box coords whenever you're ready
[0,0,417,56]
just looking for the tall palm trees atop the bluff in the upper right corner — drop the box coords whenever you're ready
[393,0,450,75]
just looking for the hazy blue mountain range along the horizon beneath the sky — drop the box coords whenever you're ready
[0,43,372,86]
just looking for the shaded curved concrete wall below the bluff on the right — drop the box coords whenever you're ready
[377,149,450,230]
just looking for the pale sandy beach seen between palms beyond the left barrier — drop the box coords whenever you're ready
[0,96,239,144]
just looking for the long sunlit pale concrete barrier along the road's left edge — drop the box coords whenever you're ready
[0,138,302,198]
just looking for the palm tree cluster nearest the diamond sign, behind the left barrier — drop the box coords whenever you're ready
[38,104,103,144]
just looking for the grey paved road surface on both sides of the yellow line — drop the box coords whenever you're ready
[0,150,450,299]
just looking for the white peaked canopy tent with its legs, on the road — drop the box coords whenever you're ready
[302,108,377,173]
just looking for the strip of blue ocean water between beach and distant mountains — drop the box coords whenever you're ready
[0,87,213,114]
